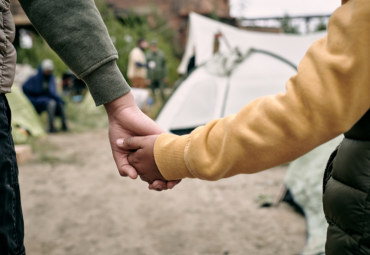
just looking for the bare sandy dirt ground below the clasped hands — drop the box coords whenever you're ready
[20,130,306,255]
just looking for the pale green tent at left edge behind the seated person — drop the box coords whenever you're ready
[6,86,45,143]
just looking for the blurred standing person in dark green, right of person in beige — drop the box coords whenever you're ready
[146,40,167,101]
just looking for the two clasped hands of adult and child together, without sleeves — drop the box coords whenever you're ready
[104,92,180,191]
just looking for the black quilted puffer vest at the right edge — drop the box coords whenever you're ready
[323,111,370,255]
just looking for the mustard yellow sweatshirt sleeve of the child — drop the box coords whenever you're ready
[154,0,370,180]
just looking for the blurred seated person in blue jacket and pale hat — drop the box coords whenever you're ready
[22,59,68,133]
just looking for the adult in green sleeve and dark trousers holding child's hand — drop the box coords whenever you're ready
[0,0,177,255]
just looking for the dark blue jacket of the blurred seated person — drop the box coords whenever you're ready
[23,66,64,113]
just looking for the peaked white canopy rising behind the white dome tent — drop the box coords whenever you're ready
[177,12,326,74]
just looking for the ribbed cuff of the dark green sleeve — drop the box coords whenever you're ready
[83,60,131,106]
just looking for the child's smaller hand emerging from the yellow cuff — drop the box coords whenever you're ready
[117,135,167,187]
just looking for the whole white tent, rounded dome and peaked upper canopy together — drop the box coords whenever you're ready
[156,13,325,135]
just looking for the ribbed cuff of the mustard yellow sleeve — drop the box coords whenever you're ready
[154,134,194,181]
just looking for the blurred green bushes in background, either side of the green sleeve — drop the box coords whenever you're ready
[17,0,180,83]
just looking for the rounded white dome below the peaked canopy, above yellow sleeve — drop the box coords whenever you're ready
[157,50,296,132]
